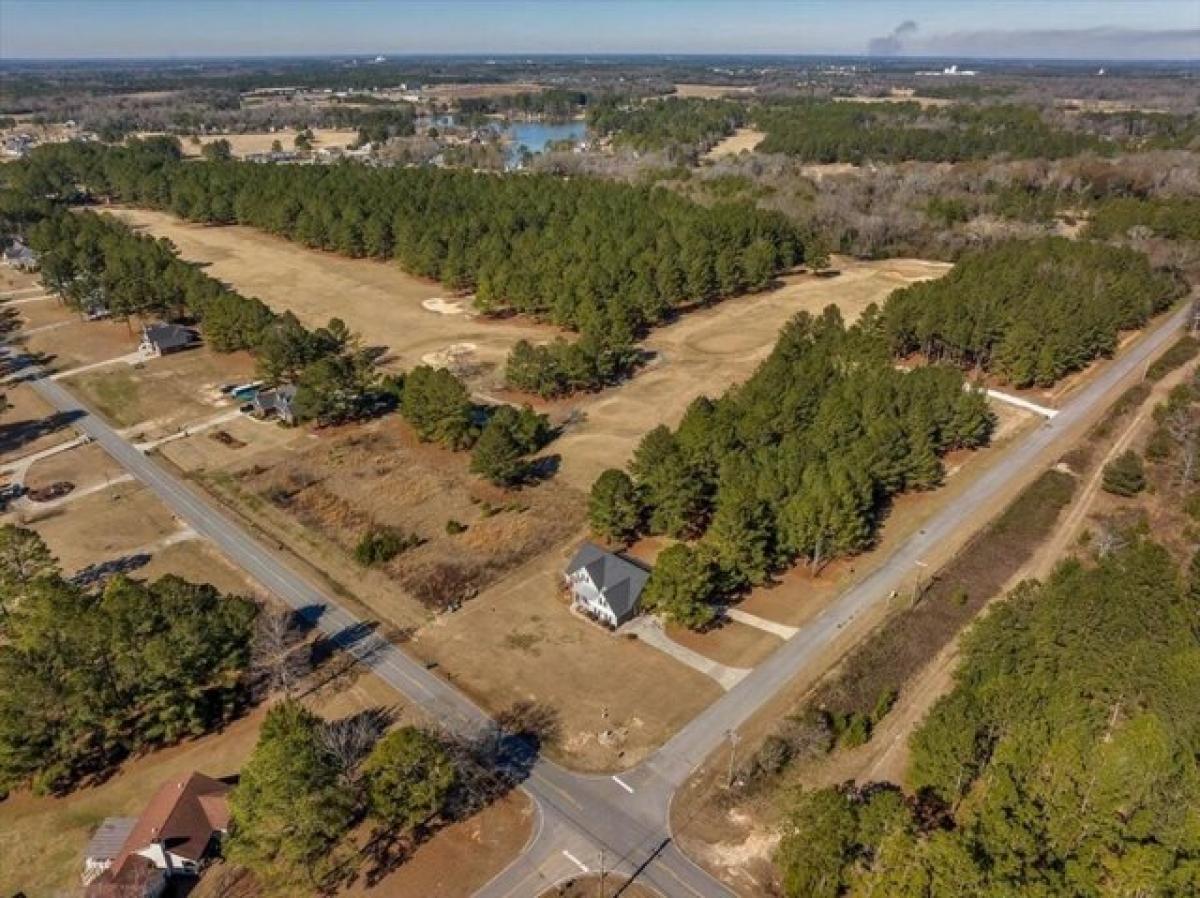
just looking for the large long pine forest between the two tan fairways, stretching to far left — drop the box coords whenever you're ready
[14,138,803,393]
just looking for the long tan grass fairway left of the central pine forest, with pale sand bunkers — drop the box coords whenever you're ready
[113,209,558,385]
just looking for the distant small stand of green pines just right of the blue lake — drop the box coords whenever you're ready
[588,97,748,151]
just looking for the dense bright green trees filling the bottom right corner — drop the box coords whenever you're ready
[776,540,1200,898]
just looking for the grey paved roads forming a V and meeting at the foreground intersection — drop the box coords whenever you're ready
[16,306,1190,898]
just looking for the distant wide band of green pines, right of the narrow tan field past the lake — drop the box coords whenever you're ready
[754,98,1117,164]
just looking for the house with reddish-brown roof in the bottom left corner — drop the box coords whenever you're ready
[84,773,230,898]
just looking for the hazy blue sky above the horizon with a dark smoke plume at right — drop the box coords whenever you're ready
[0,0,1200,59]
